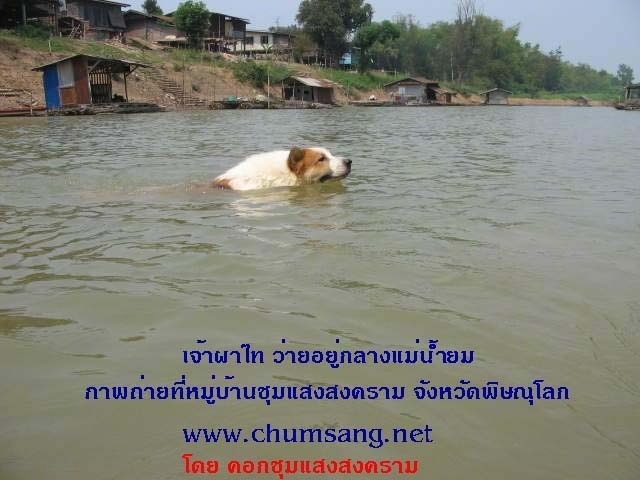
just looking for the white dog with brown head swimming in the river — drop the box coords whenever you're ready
[210,147,351,190]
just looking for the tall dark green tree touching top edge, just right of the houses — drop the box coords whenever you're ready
[296,0,373,64]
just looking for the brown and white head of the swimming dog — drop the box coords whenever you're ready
[287,147,351,183]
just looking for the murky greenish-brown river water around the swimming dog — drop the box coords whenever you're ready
[0,107,640,480]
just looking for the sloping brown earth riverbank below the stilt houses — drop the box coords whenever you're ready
[0,33,613,111]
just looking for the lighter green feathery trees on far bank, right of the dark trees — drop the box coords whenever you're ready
[369,15,632,95]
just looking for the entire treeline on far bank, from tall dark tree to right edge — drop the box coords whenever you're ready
[280,0,633,96]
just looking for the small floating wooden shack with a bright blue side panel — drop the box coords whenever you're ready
[33,54,155,110]
